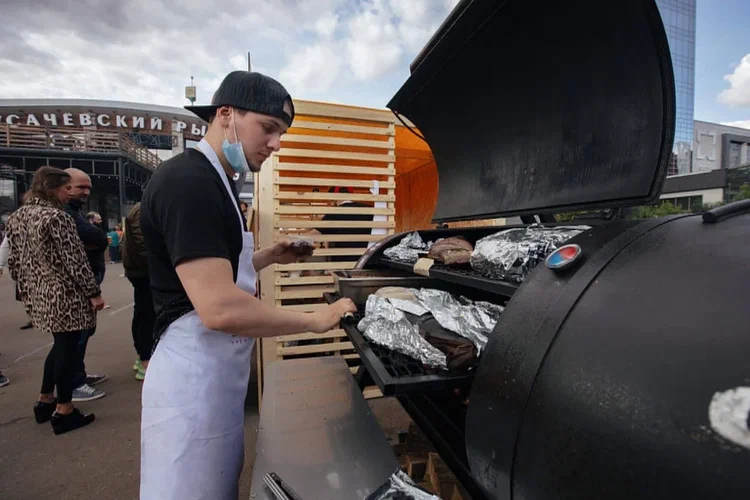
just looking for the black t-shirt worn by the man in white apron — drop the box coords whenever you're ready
[140,149,244,338]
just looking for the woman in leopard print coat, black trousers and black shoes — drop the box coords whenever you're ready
[7,167,104,434]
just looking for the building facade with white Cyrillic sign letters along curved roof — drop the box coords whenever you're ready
[0,99,206,231]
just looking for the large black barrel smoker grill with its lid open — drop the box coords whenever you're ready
[334,0,750,499]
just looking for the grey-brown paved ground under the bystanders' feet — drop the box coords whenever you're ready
[0,265,408,500]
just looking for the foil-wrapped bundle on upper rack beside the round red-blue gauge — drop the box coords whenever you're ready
[471,224,591,283]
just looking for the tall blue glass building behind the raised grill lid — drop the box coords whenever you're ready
[656,0,696,175]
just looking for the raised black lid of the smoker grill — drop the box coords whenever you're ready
[388,0,675,221]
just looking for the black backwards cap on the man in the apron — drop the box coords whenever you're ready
[185,71,294,127]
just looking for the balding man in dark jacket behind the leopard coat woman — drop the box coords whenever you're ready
[65,168,109,402]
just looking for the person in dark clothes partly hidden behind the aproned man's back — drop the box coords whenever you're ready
[120,203,156,380]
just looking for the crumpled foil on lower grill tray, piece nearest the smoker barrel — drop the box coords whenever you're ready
[415,288,503,354]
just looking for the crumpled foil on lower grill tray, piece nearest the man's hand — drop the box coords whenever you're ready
[357,295,448,370]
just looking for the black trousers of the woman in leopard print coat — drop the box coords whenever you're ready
[40,330,81,404]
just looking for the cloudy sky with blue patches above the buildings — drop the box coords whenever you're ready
[0,0,750,128]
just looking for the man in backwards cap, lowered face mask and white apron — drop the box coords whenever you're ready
[140,71,356,500]
